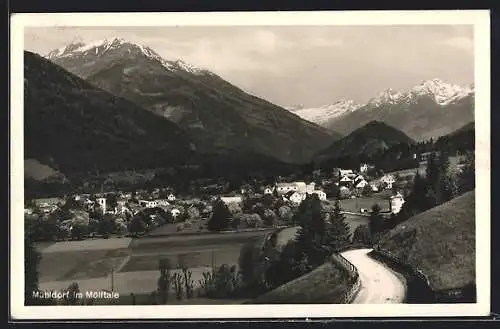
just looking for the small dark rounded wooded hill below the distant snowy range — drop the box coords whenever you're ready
[316,121,414,160]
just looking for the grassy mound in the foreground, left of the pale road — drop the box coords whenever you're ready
[248,262,349,304]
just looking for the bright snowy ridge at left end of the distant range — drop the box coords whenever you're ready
[293,99,361,125]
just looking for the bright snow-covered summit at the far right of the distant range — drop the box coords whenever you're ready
[409,79,474,105]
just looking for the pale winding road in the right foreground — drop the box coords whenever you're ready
[342,249,406,304]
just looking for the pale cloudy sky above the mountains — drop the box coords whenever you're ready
[24,25,474,107]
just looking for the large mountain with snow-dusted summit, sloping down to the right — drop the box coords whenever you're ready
[47,38,340,163]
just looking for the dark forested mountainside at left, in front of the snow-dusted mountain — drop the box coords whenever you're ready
[24,52,195,173]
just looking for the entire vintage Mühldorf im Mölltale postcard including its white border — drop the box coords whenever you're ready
[10,11,490,319]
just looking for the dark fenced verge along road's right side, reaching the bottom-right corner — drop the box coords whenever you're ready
[370,249,476,304]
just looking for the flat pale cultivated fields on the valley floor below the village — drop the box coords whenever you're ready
[39,230,269,296]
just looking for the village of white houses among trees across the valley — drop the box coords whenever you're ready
[25,164,405,241]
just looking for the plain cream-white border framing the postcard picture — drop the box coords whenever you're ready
[10,10,490,320]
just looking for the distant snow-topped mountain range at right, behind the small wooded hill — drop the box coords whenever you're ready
[289,79,474,140]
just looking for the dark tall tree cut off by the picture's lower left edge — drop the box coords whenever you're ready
[24,223,41,305]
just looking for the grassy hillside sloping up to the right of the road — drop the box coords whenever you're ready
[379,191,476,290]
